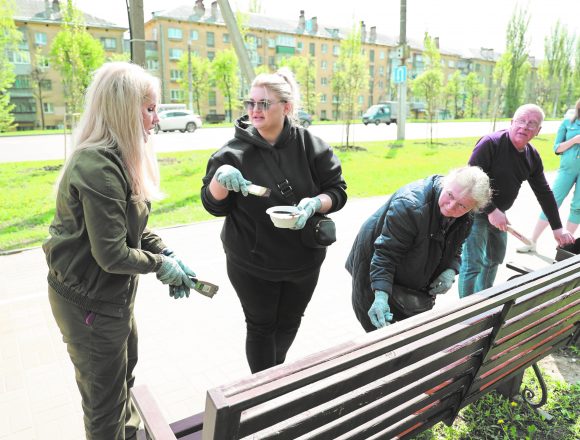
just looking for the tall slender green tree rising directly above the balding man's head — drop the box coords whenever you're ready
[504,7,530,117]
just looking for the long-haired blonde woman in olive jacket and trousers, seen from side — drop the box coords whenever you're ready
[43,62,195,440]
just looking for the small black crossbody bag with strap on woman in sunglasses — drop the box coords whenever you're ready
[259,148,336,249]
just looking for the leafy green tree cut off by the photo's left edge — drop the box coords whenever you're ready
[0,0,22,132]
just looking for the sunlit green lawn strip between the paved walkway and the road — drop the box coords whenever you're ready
[0,135,558,252]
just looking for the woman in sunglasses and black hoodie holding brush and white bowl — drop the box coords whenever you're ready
[201,69,347,373]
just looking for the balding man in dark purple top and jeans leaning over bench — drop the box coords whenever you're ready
[459,104,574,298]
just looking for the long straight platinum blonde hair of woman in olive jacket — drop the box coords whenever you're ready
[67,61,161,200]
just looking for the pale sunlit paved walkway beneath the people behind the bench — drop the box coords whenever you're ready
[0,177,568,440]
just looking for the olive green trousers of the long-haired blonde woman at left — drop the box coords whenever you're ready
[48,287,141,440]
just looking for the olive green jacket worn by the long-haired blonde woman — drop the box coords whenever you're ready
[42,147,166,317]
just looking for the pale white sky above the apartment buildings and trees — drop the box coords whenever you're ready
[73,0,580,58]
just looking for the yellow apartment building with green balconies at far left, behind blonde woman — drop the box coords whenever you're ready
[8,0,127,130]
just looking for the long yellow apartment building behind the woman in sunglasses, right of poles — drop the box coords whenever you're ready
[145,0,497,120]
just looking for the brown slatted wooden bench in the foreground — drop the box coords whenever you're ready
[132,256,580,440]
